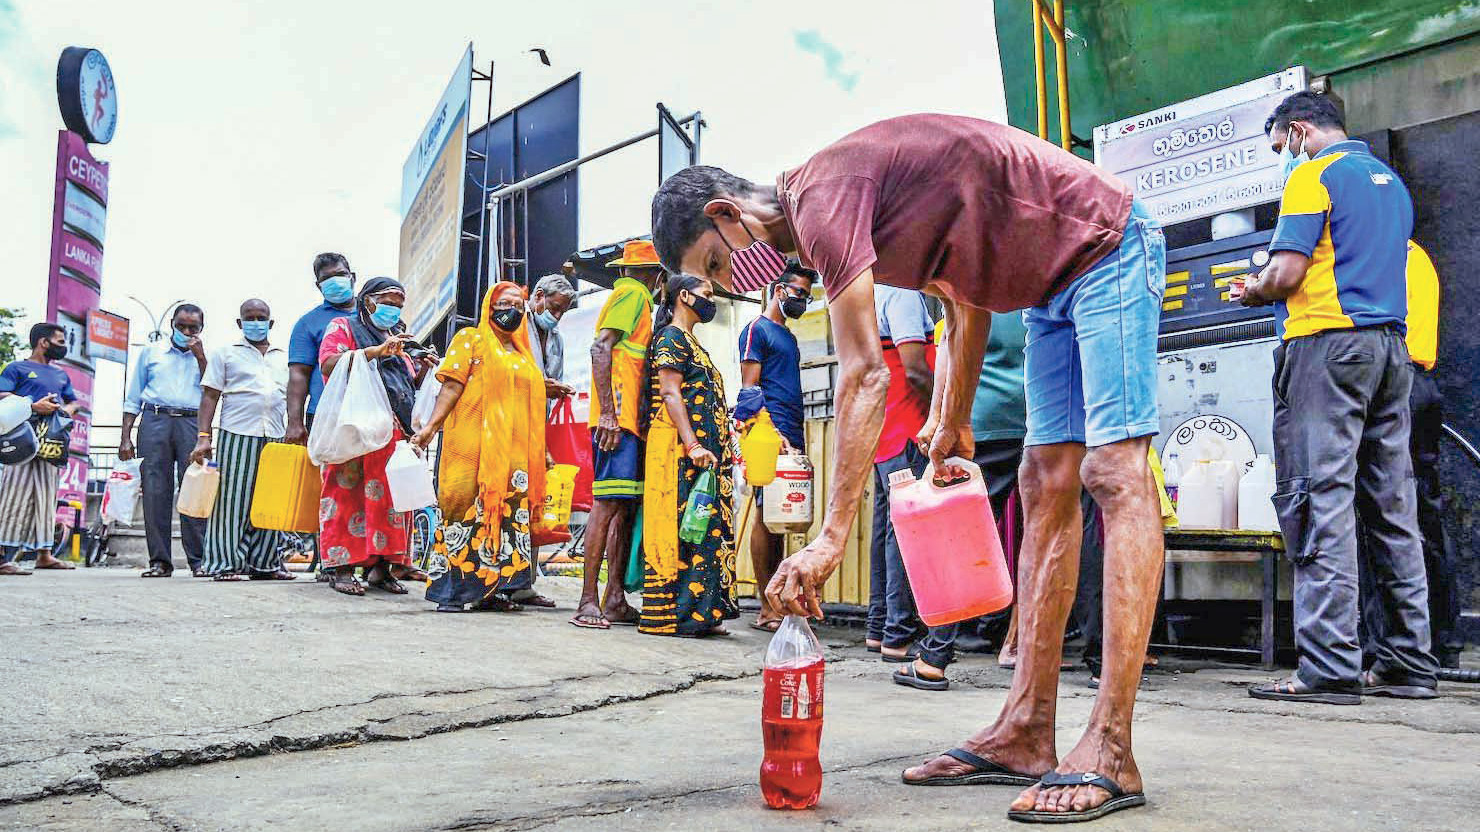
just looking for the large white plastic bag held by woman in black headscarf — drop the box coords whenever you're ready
[308,349,395,465]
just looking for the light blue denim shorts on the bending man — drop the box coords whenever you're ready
[1023,203,1166,447]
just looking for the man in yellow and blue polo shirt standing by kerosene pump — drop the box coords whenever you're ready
[1237,92,1437,705]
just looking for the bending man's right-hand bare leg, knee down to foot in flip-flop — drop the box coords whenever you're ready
[1012,438,1163,811]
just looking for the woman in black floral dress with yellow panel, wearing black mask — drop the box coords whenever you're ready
[638,274,740,638]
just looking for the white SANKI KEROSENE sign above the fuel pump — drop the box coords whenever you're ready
[1095,67,1307,225]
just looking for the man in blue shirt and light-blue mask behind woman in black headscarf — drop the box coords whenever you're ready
[284,252,355,444]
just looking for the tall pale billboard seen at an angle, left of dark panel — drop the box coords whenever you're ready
[398,44,472,338]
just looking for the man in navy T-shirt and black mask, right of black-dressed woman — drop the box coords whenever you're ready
[736,261,817,631]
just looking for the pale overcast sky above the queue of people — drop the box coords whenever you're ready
[0,0,1005,423]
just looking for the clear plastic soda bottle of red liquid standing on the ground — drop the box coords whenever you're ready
[761,616,823,808]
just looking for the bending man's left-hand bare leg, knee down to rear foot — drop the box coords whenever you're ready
[904,443,1083,782]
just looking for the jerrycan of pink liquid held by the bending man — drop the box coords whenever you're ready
[889,457,1012,626]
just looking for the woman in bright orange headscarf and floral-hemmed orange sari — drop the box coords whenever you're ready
[411,281,546,613]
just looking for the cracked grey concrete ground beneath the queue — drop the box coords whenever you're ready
[0,570,1480,832]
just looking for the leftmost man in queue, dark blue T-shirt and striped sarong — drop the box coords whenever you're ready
[0,324,81,574]
